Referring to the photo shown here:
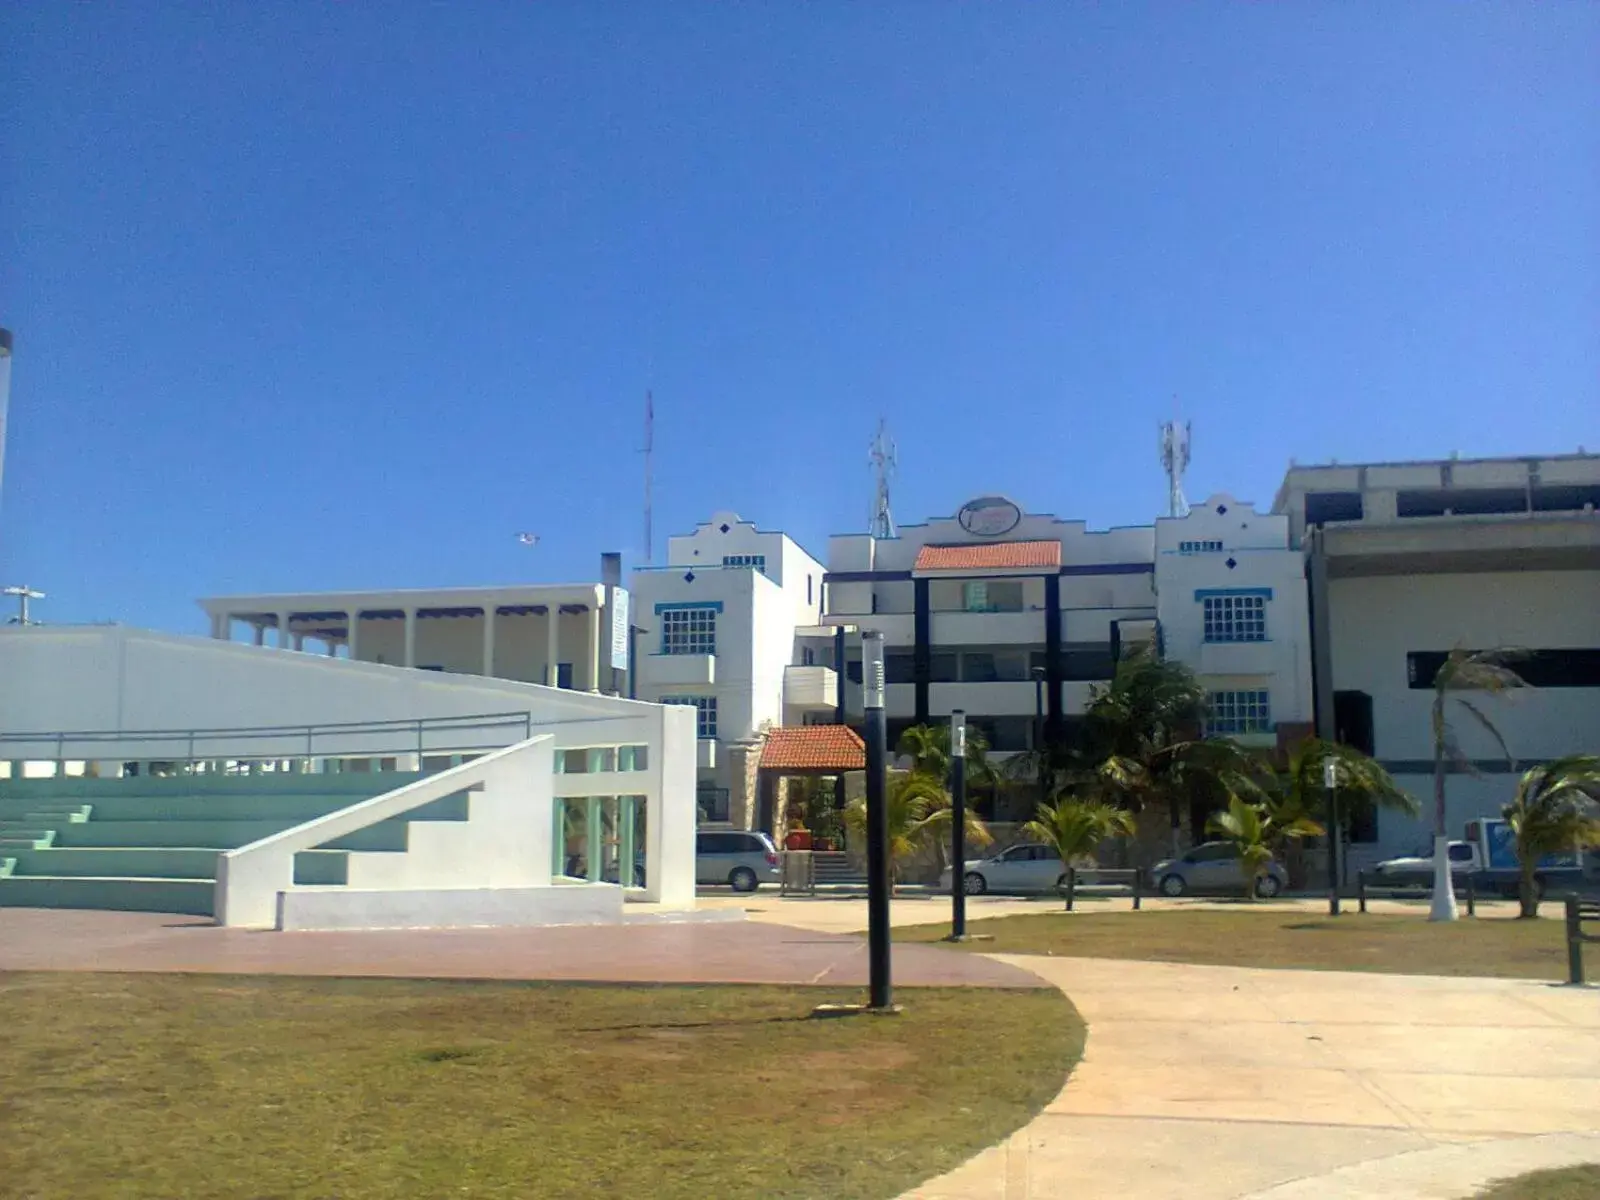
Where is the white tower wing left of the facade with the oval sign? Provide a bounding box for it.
[632,512,834,818]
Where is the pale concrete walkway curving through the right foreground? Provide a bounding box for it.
[909,957,1600,1200]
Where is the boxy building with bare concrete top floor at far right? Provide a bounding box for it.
[1274,454,1600,861]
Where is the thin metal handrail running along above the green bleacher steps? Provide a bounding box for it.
[0,710,534,762]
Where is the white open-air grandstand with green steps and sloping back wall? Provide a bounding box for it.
[0,622,694,928]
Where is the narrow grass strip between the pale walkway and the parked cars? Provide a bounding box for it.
[896,904,1566,979]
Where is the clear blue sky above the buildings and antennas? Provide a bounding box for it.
[0,2,1600,630]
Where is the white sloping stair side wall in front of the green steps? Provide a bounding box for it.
[214,733,555,926]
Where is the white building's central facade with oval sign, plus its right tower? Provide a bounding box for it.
[824,496,1310,780]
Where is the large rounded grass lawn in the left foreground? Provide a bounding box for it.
[0,973,1083,1200]
